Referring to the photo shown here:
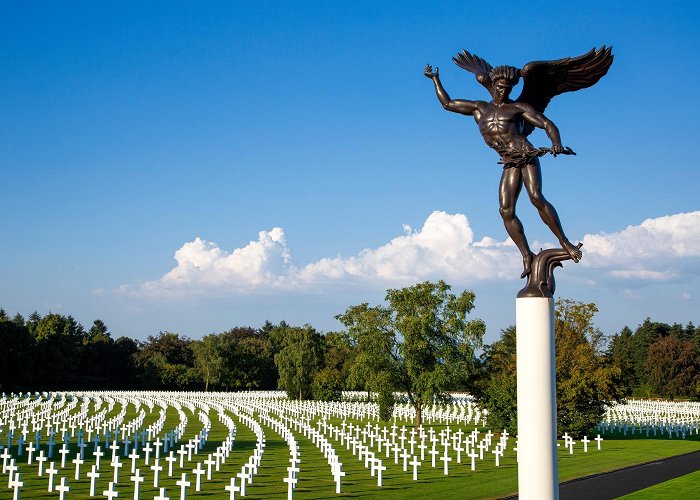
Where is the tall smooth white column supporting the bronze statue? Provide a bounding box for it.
[515,297,559,500]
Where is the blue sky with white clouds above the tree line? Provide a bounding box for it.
[0,2,700,340]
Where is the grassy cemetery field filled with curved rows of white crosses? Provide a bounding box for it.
[0,392,700,500]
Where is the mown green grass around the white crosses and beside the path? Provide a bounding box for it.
[5,405,700,500]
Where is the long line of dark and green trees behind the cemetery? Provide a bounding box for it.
[0,281,700,434]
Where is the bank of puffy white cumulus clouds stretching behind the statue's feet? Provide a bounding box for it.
[121,211,700,296]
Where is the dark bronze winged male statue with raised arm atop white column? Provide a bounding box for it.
[424,46,613,292]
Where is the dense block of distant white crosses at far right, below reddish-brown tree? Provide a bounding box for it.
[598,399,700,439]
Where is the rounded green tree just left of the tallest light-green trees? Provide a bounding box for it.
[275,324,323,399]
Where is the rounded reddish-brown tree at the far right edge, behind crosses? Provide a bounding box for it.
[645,335,700,399]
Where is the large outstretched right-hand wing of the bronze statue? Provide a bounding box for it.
[517,45,613,136]
